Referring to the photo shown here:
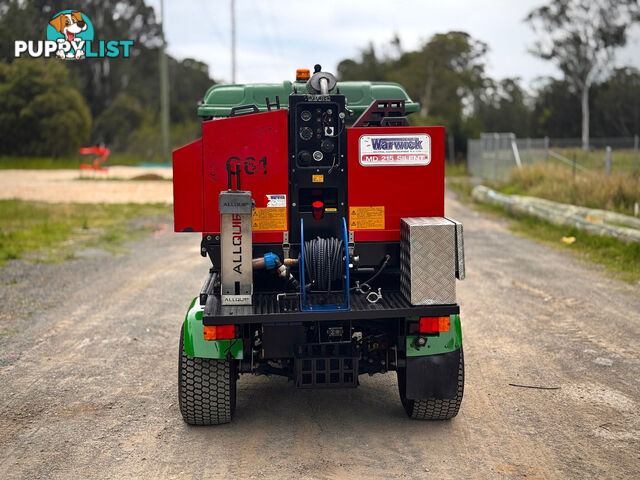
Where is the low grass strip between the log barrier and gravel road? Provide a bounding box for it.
[447,178,640,284]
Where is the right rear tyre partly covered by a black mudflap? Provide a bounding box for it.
[398,347,464,420]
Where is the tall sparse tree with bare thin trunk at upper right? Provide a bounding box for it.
[526,0,640,149]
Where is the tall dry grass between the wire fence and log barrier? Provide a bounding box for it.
[490,164,640,215]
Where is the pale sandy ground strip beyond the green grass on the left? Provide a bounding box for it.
[0,167,173,203]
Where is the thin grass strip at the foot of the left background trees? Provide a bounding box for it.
[0,153,162,170]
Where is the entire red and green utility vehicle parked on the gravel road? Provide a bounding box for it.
[173,65,464,424]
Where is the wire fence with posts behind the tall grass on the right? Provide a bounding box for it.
[467,132,640,180]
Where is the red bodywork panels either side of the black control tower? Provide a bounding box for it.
[173,116,444,243]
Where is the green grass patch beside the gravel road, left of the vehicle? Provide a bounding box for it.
[0,200,171,265]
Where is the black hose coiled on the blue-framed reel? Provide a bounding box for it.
[304,237,345,292]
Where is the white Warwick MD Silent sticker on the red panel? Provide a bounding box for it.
[359,133,431,167]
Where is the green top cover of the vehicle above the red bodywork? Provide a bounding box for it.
[198,81,420,118]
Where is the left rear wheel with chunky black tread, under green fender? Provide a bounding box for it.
[178,326,236,425]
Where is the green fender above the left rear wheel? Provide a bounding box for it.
[184,297,243,360]
